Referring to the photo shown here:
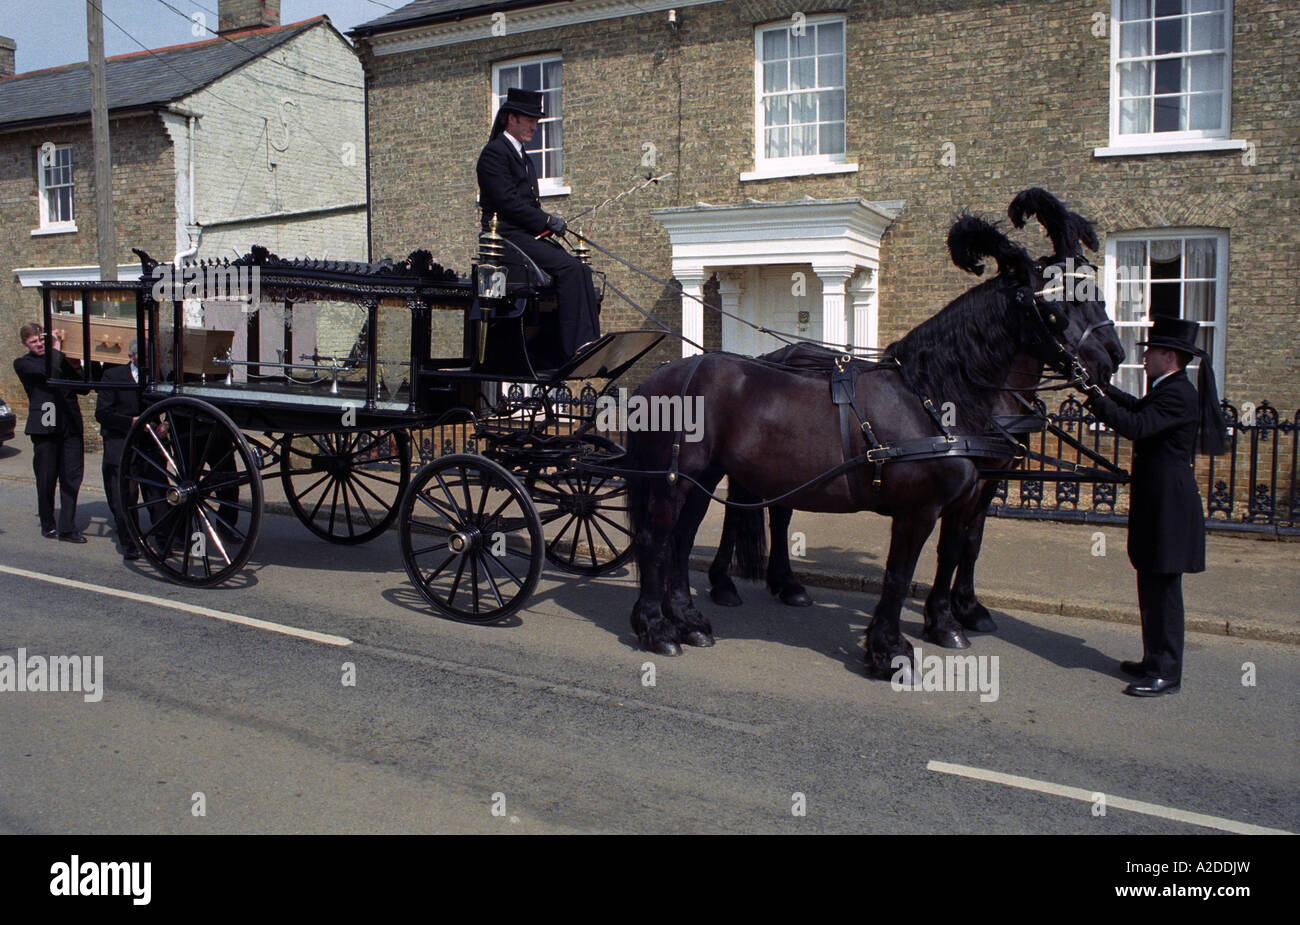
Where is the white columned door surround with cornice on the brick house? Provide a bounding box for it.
[650,197,904,356]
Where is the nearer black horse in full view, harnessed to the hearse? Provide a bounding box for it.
[628,190,1122,677]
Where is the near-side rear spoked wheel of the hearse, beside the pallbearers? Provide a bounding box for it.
[118,398,261,587]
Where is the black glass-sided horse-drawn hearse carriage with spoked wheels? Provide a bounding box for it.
[42,239,663,622]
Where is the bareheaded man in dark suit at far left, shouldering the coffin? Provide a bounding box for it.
[13,322,90,543]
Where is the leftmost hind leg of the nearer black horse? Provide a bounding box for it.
[629,479,681,655]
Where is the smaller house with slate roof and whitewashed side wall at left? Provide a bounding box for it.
[0,0,367,409]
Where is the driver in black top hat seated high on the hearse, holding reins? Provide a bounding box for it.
[477,87,601,356]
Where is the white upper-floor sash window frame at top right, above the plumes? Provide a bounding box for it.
[1093,0,1247,157]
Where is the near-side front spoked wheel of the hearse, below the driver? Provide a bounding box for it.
[398,453,543,624]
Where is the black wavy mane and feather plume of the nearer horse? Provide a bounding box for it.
[885,214,1034,429]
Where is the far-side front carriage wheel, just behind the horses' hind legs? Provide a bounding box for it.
[528,434,632,576]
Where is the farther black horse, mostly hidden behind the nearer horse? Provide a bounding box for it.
[709,188,1125,633]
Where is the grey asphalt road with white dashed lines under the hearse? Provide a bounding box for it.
[0,474,1300,834]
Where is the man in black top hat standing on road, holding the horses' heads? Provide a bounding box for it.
[1086,317,1226,696]
